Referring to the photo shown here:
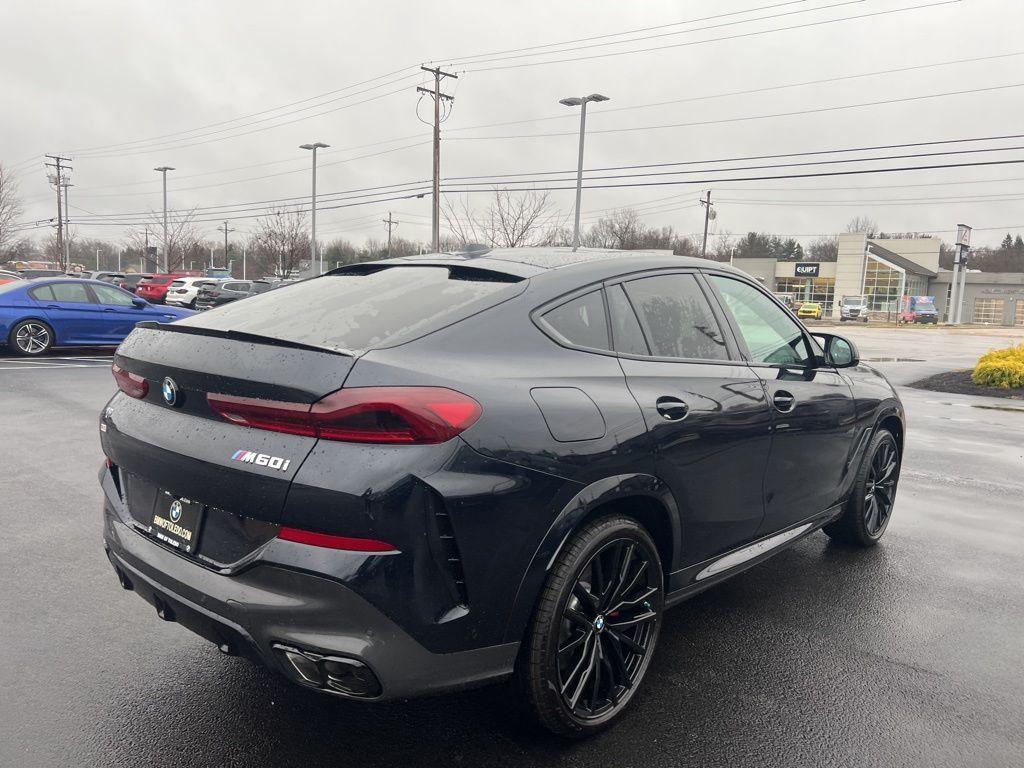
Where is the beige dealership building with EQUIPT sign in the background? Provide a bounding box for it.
[733,232,1024,327]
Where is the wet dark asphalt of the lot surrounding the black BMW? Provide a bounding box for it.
[0,328,1024,768]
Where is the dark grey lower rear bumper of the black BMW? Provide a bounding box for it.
[103,480,519,700]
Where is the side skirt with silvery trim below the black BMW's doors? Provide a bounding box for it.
[665,504,843,607]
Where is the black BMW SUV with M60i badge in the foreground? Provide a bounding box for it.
[99,249,904,735]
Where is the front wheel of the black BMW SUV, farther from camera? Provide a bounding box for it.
[822,429,902,547]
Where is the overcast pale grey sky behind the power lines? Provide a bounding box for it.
[0,0,1024,244]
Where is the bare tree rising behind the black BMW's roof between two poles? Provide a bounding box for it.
[441,187,565,248]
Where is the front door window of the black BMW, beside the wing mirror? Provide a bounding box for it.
[710,275,811,366]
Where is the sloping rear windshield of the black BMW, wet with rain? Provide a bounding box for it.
[177,266,525,352]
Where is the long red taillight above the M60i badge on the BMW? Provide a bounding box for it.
[207,387,483,444]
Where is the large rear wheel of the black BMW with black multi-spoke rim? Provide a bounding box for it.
[516,515,665,738]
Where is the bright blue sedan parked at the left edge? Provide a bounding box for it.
[0,278,195,355]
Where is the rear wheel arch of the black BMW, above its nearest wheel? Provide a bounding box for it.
[505,474,682,641]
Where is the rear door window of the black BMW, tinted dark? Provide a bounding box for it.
[626,273,729,360]
